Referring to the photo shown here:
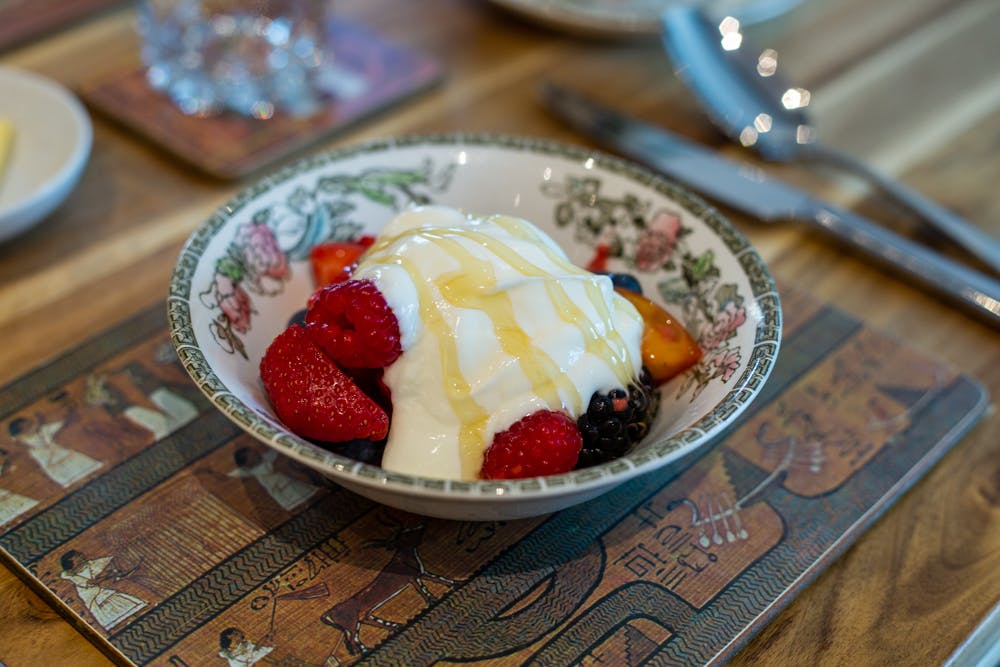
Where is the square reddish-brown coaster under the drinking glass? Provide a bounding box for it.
[80,22,442,179]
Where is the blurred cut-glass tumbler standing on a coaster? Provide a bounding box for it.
[137,0,340,119]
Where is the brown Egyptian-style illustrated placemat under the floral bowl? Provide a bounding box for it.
[0,292,987,667]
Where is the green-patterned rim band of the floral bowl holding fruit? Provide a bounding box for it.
[167,132,782,504]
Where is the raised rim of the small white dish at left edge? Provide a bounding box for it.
[0,66,94,232]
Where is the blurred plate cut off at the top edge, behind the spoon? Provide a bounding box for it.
[493,0,800,37]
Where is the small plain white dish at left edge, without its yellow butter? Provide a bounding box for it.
[0,67,93,242]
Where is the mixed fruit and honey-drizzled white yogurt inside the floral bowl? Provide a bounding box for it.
[261,205,701,481]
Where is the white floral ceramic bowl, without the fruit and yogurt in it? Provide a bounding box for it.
[168,135,781,520]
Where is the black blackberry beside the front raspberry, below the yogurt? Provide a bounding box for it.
[576,368,660,468]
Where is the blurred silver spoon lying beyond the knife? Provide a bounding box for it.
[663,4,1000,273]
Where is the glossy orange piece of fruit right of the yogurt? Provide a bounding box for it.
[615,287,702,385]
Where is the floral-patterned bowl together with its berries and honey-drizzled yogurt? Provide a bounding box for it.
[168,135,780,520]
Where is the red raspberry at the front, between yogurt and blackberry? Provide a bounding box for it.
[479,410,583,479]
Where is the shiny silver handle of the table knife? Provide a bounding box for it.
[809,204,1000,328]
